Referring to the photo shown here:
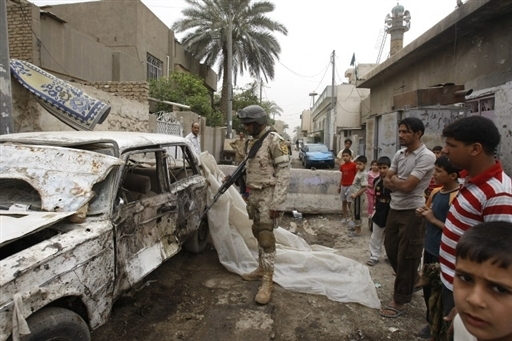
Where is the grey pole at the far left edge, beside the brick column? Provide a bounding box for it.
[0,0,14,135]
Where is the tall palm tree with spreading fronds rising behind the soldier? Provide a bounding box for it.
[172,0,288,119]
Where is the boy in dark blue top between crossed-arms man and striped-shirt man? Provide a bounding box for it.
[416,155,460,338]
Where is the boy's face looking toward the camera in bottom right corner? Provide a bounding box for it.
[453,221,512,341]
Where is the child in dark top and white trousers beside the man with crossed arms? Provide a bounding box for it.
[366,156,391,266]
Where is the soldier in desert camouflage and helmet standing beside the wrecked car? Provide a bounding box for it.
[237,105,290,304]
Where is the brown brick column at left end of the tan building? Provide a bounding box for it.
[7,0,34,63]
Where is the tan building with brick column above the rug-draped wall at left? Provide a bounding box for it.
[7,0,217,90]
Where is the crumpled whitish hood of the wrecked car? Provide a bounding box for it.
[0,143,122,244]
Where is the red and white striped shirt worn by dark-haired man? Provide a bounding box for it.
[439,161,512,290]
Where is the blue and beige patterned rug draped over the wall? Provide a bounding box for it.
[10,59,110,130]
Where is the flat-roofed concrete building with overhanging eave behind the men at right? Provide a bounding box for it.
[358,0,512,174]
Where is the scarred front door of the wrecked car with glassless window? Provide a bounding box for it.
[114,149,179,297]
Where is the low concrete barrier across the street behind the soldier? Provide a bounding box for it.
[219,165,366,214]
